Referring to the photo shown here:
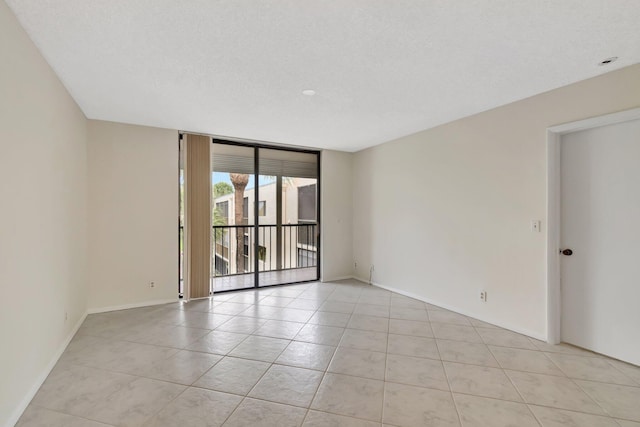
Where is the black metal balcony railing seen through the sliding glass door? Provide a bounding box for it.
[212,224,318,277]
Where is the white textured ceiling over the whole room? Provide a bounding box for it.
[6,0,640,151]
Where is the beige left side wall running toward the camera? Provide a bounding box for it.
[0,1,87,426]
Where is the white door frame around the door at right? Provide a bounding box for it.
[547,107,640,344]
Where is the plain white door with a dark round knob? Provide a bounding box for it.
[561,120,640,364]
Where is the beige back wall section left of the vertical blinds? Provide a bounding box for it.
[88,120,178,311]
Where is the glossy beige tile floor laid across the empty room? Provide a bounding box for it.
[18,281,640,427]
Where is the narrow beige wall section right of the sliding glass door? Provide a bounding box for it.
[320,150,356,282]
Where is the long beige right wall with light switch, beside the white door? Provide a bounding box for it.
[353,65,640,338]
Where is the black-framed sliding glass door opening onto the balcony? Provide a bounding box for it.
[211,140,320,292]
